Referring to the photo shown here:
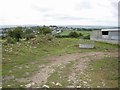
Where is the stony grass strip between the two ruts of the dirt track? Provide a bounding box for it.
[46,61,75,88]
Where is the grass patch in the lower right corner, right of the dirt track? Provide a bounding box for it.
[81,57,118,88]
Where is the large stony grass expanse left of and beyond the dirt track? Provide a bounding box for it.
[2,34,118,87]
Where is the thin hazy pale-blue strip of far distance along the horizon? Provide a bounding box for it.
[0,25,117,29]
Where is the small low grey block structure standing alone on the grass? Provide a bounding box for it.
[79,39,94,48]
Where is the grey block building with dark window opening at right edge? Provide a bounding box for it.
[90,29,120,44]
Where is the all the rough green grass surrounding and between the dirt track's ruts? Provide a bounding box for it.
[2,35,118,88]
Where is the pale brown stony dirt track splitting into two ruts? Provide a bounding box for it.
[18,52,117,87]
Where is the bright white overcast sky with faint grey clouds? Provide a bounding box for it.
[0,0,119,26]
